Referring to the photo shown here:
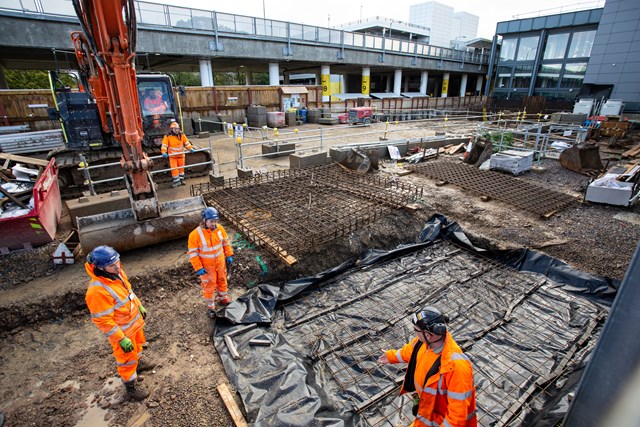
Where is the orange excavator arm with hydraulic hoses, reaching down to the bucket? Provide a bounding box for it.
[71,0,153,199]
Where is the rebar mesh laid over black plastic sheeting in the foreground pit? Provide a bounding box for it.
[272,242,604,426]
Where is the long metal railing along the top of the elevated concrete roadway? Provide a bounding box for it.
[0,0,489,65]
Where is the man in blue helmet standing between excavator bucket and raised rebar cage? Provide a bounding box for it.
[188,207,233,318]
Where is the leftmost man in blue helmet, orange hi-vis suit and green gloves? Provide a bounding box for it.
[85,246,152,401]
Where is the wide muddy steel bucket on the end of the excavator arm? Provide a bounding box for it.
[77,196,206,253]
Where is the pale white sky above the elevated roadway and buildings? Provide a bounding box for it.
[144,0,604,39]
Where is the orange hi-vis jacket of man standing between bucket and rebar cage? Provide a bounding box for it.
[187,224,233,271]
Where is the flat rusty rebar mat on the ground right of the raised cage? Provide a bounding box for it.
[409,162,574,217]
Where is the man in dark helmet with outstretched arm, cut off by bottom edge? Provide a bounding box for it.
[378,306,478,427]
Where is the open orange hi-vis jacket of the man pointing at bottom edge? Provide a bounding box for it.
[385,332,478,427]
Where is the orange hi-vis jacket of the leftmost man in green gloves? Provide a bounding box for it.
[85,263,144,345]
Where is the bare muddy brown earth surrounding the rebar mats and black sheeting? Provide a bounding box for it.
[0,121,640,426]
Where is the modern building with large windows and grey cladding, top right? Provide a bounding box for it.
[485,0,640,111]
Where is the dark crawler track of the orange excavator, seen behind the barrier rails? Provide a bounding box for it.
[51,147,211,200]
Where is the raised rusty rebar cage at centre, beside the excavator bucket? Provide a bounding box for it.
[192,165,422,265]
